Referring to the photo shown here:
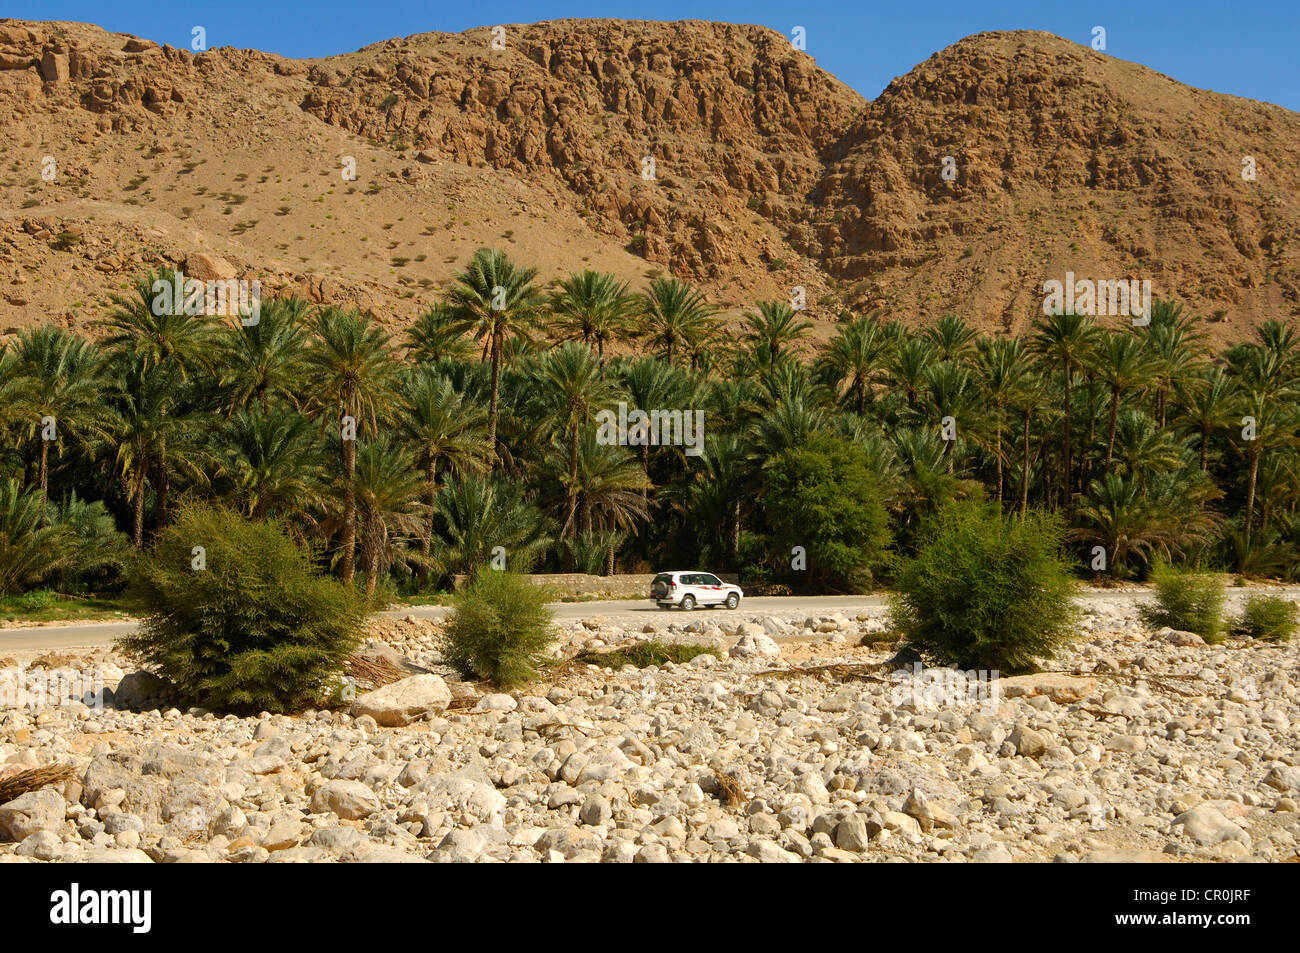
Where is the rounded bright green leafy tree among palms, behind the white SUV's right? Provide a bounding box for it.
[762,434,889,589]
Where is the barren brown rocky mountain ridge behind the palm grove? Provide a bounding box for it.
[0,20,1300,338]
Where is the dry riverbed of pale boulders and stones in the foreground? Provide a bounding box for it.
[0,593,1300,863]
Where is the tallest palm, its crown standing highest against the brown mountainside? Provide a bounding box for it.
[447,248,542,467]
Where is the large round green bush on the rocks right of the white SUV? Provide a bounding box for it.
[891,502,1078,673]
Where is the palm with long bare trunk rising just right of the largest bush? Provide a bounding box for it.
[307,308,395,582]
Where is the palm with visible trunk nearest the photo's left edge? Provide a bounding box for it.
[10,324,105,499]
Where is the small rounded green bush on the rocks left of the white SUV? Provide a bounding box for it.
[446,569,553,688]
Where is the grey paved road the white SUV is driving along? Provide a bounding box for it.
[10,588,1300,653]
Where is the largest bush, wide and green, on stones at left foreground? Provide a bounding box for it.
[121,503,365,711]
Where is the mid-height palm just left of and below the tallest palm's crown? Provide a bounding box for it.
[398,368,491,556]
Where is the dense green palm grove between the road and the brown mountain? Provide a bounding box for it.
[0,250,1300,595]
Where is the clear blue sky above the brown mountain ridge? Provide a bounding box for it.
[12,0,1300,112]
